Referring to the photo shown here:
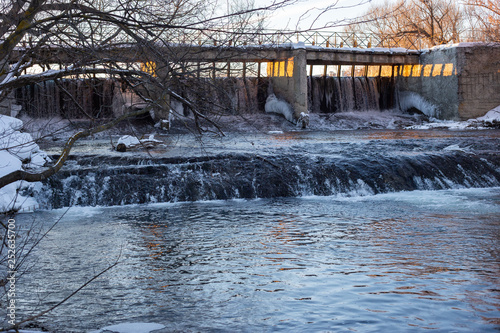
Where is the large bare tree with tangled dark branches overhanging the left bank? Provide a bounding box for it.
[0,0,304,188]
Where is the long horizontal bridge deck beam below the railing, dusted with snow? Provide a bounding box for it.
[11,44,420,65]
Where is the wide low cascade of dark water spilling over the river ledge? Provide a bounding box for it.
[36,147,500,208]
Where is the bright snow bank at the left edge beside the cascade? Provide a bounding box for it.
[0,115,49,212]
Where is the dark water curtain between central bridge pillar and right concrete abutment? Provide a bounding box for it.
[308,77,395,113]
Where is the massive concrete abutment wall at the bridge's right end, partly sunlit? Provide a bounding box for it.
[397,43,500,120]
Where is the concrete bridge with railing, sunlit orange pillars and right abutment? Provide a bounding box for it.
[7,31,500,119]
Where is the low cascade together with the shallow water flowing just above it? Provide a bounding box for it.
[36,130,500,208]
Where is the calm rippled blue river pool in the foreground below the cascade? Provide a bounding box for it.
[13,188,500,332]
